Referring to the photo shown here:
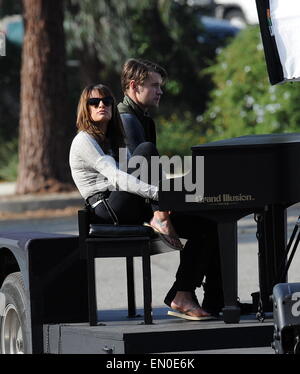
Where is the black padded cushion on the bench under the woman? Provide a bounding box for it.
[89,223,156,238]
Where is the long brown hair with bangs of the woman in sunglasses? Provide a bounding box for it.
[76,84,125,160]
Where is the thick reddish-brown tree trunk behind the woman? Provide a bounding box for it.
[16,0,73,194]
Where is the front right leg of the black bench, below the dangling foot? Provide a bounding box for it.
[142,250,152,325]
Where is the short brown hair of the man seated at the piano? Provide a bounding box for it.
[121,58,167,92]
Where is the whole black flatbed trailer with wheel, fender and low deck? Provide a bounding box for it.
[0,232,273,354]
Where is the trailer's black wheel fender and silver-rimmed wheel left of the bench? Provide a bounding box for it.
[0,232,87,353]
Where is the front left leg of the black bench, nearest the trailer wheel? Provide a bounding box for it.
[87,248,97,326]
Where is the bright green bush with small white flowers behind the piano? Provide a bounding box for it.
[202,27,300,140]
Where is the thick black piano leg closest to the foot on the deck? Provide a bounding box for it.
[218,222,240,323]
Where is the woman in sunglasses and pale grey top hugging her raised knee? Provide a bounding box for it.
[70,85,182,245]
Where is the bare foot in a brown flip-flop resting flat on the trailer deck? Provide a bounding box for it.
[171,291,210,317]
